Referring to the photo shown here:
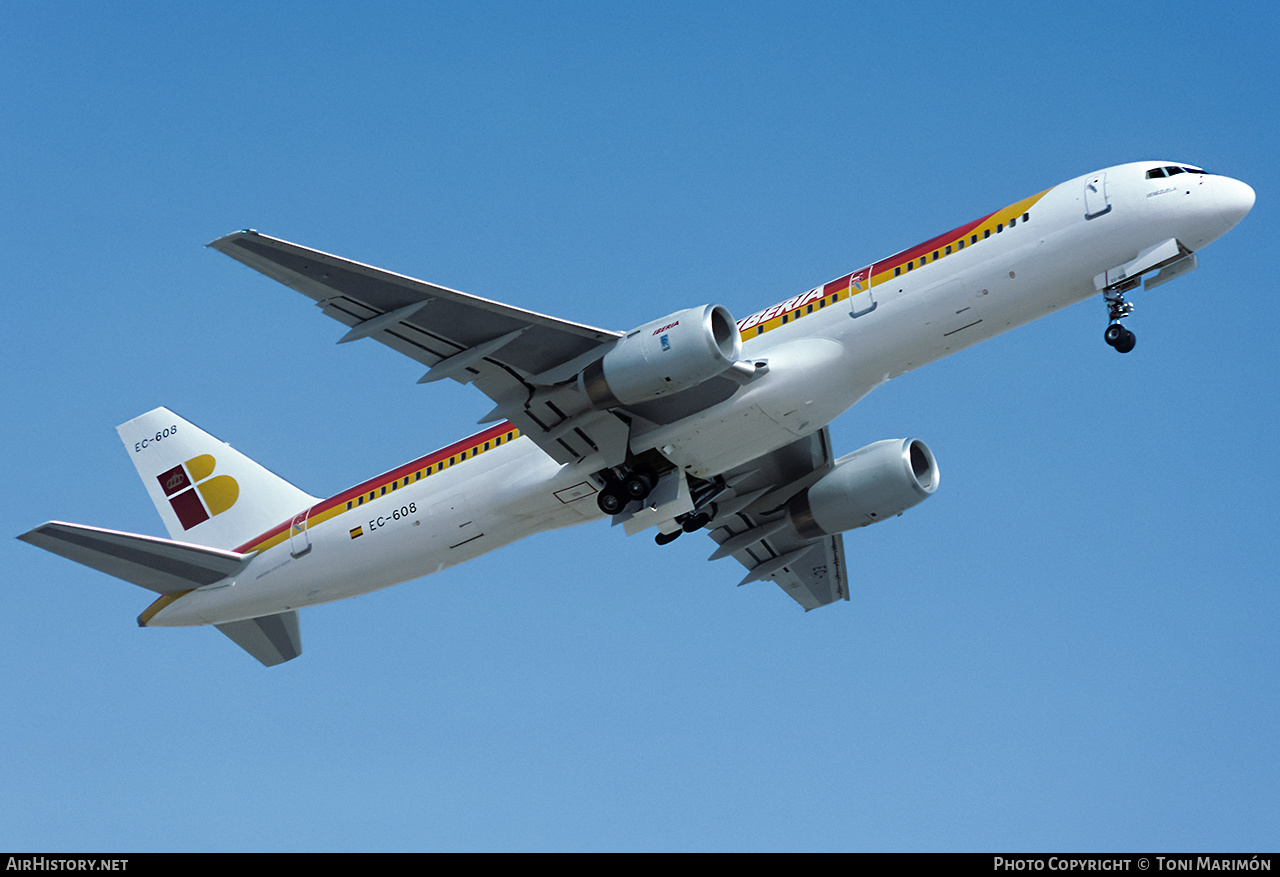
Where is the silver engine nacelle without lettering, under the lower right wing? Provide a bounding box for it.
[787,439,938,539]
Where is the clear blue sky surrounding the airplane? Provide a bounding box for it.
[0,1,1280,851]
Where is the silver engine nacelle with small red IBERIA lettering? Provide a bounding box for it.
[579,305,742,408]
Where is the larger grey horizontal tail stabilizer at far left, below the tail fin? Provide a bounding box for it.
[18,521,253,594]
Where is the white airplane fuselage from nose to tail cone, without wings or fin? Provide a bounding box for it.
[146,161,1253,626]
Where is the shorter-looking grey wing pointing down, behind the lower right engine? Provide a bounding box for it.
[708,428,849,611]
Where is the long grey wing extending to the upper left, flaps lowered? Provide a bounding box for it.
[209,230,630,465]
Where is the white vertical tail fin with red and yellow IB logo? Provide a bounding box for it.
[115,408,316,548]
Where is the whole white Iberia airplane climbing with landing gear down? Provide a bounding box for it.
[18,161,1254,666]
